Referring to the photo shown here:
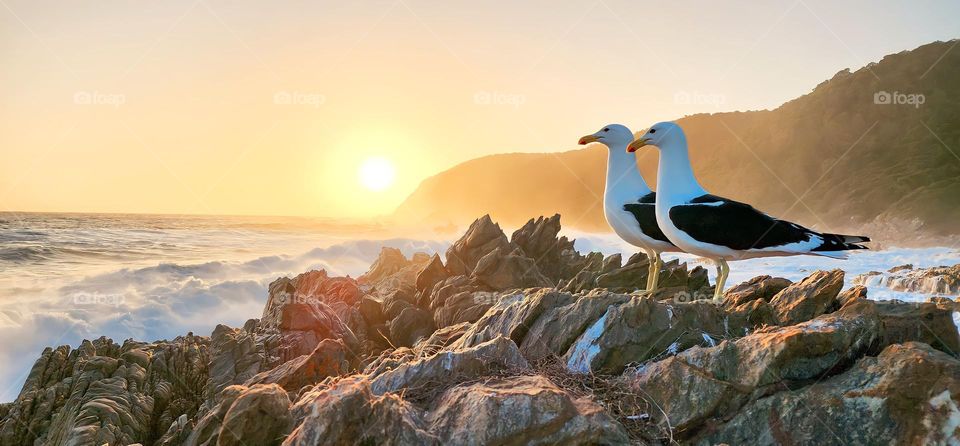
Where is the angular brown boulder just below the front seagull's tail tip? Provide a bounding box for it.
[770,269,843,325]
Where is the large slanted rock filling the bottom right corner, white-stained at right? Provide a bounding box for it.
[697,342,960,445]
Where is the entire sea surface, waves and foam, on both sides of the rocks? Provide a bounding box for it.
[0,213,960,401]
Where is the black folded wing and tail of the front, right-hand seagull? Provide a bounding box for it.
[670,194,870,251]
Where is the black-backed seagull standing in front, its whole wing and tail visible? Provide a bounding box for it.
[627,122,870,303]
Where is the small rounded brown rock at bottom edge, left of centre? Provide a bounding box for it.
[216,384,293,446]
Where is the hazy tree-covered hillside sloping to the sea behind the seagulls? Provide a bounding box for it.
[395,41,960,242]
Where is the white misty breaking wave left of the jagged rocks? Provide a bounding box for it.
[0,238,449,401]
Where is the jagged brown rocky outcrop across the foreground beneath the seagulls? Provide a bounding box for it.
[0,217,960,446]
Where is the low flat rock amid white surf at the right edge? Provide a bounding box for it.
[853,264,960,296]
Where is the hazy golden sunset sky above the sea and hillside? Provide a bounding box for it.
[0,0,960,217]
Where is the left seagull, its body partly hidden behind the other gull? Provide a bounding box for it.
[580,124,680,292]
